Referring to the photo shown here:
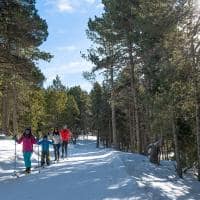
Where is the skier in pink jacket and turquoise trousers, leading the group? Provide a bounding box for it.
[17,128,37,173]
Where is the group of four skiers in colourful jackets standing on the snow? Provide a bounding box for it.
[15,125,72,173]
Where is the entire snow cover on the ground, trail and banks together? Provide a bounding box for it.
[0,136,200,200]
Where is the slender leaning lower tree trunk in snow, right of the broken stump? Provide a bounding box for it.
[172,113,183,178]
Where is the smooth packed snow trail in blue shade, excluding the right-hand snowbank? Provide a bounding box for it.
[0,139,138,200]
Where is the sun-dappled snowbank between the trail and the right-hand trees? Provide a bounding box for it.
[119,153,200,200]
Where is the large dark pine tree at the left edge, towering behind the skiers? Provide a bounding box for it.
[0,0,51,132]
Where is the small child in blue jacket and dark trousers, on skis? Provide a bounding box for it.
[38,135,53,167]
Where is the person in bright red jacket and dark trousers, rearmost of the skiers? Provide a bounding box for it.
[60,125,72,158]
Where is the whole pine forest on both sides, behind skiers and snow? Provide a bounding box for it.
[0,0,200,180]
